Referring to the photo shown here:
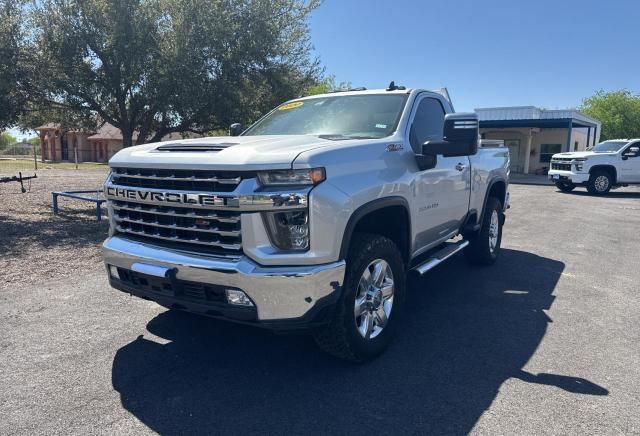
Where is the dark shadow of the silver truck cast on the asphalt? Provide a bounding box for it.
[112,249,608,434]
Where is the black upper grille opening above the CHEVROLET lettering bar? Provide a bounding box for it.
[111,168,248,192]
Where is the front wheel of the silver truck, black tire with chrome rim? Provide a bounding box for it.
[314,234,405,362]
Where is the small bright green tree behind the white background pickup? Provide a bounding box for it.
[580,89,640,140]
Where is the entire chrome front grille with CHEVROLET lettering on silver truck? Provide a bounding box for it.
[104,168,310,257]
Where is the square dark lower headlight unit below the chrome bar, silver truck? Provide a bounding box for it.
[264,210,309,251]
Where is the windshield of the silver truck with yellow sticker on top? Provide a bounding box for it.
[245,94,407,139]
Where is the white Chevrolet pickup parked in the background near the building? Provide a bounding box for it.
[549,139,640,195]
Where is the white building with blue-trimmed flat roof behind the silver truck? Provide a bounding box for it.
[476,106,601,174]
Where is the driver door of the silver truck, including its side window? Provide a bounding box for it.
[409,93,471,251]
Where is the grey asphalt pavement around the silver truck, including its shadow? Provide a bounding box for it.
[0,185,640,435]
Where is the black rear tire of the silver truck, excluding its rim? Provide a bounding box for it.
[464,197,504,265]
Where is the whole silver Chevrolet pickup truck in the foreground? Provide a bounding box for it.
[104,86,509,361]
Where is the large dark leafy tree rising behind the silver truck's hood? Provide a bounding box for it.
[30,0,321,146]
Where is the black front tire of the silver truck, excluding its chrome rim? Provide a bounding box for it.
[313,233,406,362]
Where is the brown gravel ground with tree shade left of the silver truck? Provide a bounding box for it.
[0,168,108,290]
